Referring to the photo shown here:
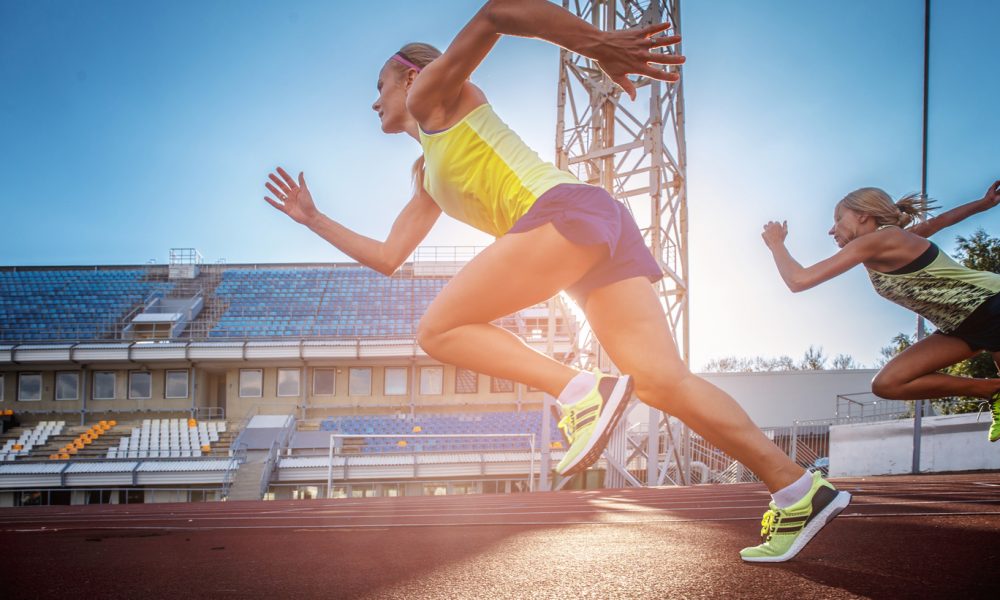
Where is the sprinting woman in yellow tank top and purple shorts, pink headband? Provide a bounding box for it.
[265,0,850,561]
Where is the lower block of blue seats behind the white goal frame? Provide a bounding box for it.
[320,411,564,453]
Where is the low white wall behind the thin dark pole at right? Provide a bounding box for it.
[830,414,1000,477]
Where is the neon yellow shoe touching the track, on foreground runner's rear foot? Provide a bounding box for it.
[740,471,851,562]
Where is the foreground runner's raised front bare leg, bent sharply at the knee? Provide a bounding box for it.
[417,224,607,396]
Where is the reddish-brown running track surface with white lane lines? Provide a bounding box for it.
[0,473,1000,600]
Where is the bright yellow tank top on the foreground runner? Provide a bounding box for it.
[420,104,581,237]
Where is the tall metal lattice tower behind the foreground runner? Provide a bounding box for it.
[556,0,689,487]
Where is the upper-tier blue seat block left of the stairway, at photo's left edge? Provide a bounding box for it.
[0,269,172,341]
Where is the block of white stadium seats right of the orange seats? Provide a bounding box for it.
[107,419,226,458]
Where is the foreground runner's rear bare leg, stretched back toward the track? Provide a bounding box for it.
[584,278,804,492]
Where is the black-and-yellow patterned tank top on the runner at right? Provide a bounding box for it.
[868,243,1000,333]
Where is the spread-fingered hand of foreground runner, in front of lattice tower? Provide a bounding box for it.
[588,23,684,100]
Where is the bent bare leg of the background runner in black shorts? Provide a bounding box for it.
[872,335,1000,400]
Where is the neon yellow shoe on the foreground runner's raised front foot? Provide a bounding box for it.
[556,371,632,477]
